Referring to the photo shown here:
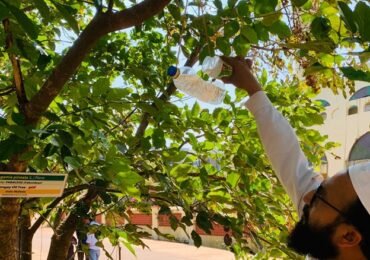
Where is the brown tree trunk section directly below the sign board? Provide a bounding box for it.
[0,198,20,260]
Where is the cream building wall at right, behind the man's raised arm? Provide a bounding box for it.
[317,82,370,176]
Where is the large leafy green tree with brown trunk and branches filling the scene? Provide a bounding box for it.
[0,0,370,259]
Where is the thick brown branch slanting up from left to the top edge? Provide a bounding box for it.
[26,0,170,124]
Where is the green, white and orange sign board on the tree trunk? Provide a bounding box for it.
[0,172,67,197]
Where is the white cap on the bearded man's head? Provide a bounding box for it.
[349,162,370,214]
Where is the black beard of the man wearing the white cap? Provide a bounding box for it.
[288,205,339,259]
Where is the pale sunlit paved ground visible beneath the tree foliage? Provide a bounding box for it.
[32,227,234,260]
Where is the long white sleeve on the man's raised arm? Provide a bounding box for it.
[245,91,322,215]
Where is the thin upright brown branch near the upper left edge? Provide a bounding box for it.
[3,19,28,113]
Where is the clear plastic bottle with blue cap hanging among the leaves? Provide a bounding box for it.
[167,66,226,104]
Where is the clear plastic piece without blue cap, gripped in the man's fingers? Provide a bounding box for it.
[202,56,233,79]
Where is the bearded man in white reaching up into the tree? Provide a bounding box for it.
[222,57,370,260]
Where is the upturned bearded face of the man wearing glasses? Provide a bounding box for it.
[288,173,356,259]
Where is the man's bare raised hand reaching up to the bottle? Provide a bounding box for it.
[221,56,262,96]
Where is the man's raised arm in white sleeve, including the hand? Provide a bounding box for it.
[223,57,322,214]
